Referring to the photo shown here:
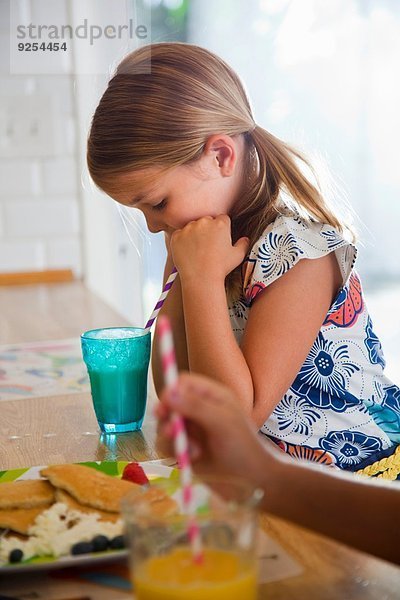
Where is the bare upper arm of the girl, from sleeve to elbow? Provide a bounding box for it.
[242,252,342,426]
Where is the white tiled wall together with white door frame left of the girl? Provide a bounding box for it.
[0,0,150,325]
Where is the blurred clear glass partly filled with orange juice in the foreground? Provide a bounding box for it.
[122,476,263,600]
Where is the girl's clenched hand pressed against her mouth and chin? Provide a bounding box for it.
[170,215,249,282]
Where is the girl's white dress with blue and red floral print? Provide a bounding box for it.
[229,215,400,470]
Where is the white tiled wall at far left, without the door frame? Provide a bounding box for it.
[0,0,82,276]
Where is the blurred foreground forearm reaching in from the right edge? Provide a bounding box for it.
[258,438,400,564]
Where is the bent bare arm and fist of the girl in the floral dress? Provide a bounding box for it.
[171,215,341,427]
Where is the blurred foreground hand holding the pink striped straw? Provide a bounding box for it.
[156,373,272,484]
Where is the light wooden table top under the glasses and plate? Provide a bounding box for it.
[0,281,400,600]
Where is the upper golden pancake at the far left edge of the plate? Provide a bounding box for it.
[0,479,54,510]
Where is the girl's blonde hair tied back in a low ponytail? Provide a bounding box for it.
[87,42,345,302]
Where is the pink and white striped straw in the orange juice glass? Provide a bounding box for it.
[157,316,203,563]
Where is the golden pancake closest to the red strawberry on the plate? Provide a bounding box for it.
[40,464,141,513]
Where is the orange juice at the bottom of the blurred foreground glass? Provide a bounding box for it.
[133,547,257,600]
